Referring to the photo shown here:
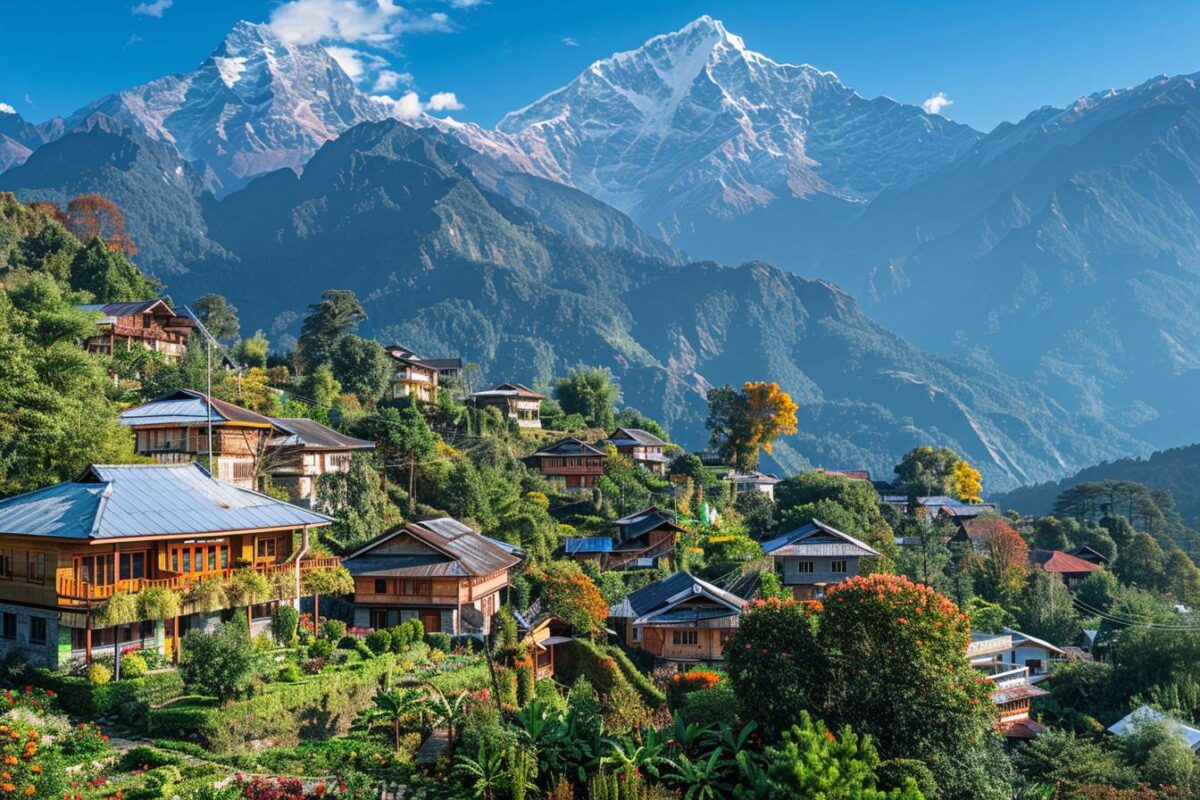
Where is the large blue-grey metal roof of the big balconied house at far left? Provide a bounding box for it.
[0,463,332,539]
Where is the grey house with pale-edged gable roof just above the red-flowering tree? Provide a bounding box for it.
[762,519,878,600]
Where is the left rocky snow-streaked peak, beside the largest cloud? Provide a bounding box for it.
[66,22,390,194]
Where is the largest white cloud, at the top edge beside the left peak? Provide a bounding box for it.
[270,0,451,47]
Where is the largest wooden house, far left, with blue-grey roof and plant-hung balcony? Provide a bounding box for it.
[0,464,338,667]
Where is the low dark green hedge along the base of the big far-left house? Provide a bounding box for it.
[29,668,184,728]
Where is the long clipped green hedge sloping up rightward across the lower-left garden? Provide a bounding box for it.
[142,654,395,754]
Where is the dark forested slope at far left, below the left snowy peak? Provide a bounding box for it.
[0,114,229,279]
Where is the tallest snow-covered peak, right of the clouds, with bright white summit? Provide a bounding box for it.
[482,17,978,265]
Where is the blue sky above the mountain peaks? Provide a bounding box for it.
[0,0,1200,130]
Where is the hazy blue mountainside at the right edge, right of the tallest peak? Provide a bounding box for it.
[824,76,1200,446]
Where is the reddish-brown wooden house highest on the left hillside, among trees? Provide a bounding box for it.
[79,300,192,362]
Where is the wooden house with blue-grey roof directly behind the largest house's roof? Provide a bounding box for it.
[120,389,284,488]
